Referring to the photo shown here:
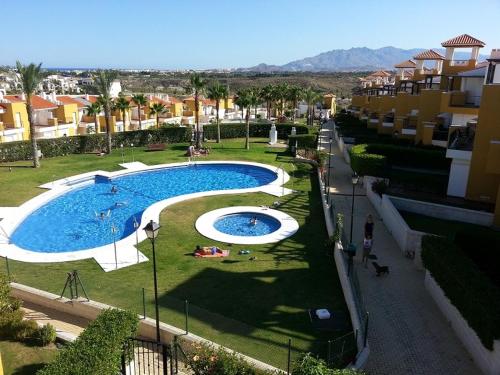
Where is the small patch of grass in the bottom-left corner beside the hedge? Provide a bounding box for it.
[0,340,57,375]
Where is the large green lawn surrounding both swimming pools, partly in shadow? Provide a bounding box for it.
[0,140,346,366]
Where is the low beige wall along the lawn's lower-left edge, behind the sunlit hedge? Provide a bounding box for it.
[11,283,282,373]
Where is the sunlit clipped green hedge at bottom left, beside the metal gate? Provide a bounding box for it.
[37,309,139,375]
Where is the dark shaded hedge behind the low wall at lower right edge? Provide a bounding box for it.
[422,236,500,350]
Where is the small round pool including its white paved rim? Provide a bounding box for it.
[195,206,299,245]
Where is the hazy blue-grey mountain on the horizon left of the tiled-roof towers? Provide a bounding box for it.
[238,47,486,73]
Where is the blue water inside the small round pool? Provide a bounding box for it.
[214,212,281,236]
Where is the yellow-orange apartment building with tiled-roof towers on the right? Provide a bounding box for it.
[349,34,500,226]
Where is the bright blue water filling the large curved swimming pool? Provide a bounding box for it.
[11,164,276,252]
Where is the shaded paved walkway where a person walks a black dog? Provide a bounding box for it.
[322,122,481,375]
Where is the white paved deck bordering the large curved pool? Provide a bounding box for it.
[0,161,292,272]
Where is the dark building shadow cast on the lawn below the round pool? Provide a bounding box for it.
[160,170,346,355]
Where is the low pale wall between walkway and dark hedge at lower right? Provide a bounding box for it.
[425,271,500,375]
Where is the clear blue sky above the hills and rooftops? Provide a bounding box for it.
[0,0,500,69]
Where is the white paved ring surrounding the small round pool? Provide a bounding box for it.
[195,206,299,245]
